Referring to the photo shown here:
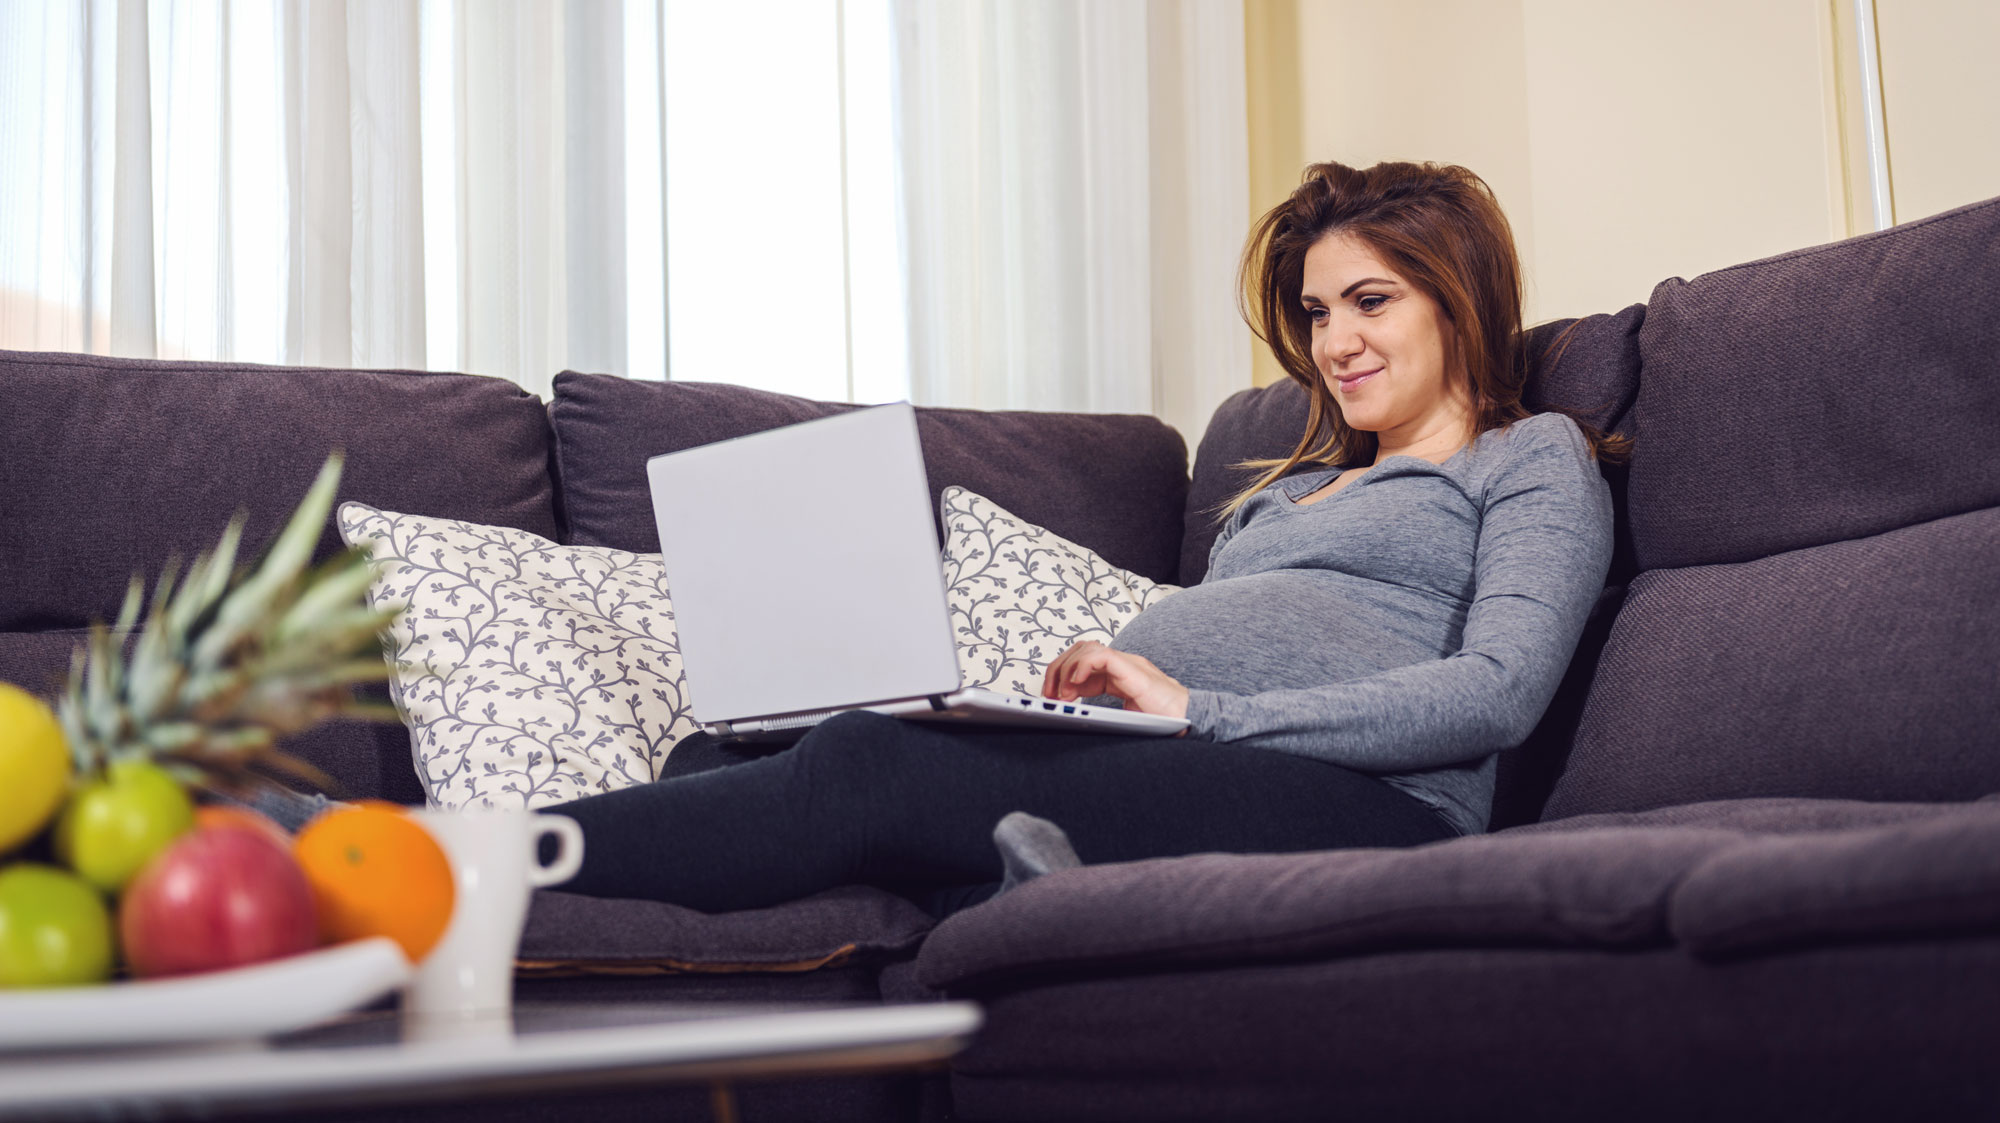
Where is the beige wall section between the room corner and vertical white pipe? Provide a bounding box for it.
[1520,0,1846,322]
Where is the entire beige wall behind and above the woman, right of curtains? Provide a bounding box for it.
[1246,0,2000,384]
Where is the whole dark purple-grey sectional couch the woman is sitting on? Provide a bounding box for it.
[0,191,2000,1119]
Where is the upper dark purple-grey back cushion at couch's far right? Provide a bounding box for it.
[1630,190,2000,569]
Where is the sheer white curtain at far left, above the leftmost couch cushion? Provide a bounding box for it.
[0,0,666,392]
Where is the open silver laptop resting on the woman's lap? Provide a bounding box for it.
[646,404,1188,739]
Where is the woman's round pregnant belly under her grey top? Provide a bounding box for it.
[1112,569,1466,693]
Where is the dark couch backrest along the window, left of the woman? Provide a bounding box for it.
[0,352,1188,803]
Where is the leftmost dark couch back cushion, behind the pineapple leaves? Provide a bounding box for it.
[0,352,556,631]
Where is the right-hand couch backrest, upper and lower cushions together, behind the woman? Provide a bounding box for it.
[1546,200,2000,817]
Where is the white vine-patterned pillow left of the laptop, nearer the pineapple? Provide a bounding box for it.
[340,504,696,809]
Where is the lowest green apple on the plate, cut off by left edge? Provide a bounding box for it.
[0,861,112,987]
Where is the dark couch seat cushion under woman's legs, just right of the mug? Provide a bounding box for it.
[518,885,934,973]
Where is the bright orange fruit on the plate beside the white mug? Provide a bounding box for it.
[292,801,456,963]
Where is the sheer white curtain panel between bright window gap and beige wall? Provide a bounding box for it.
[896,0,1250,442]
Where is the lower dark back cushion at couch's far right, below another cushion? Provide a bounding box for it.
[1546,508,2000,817]
